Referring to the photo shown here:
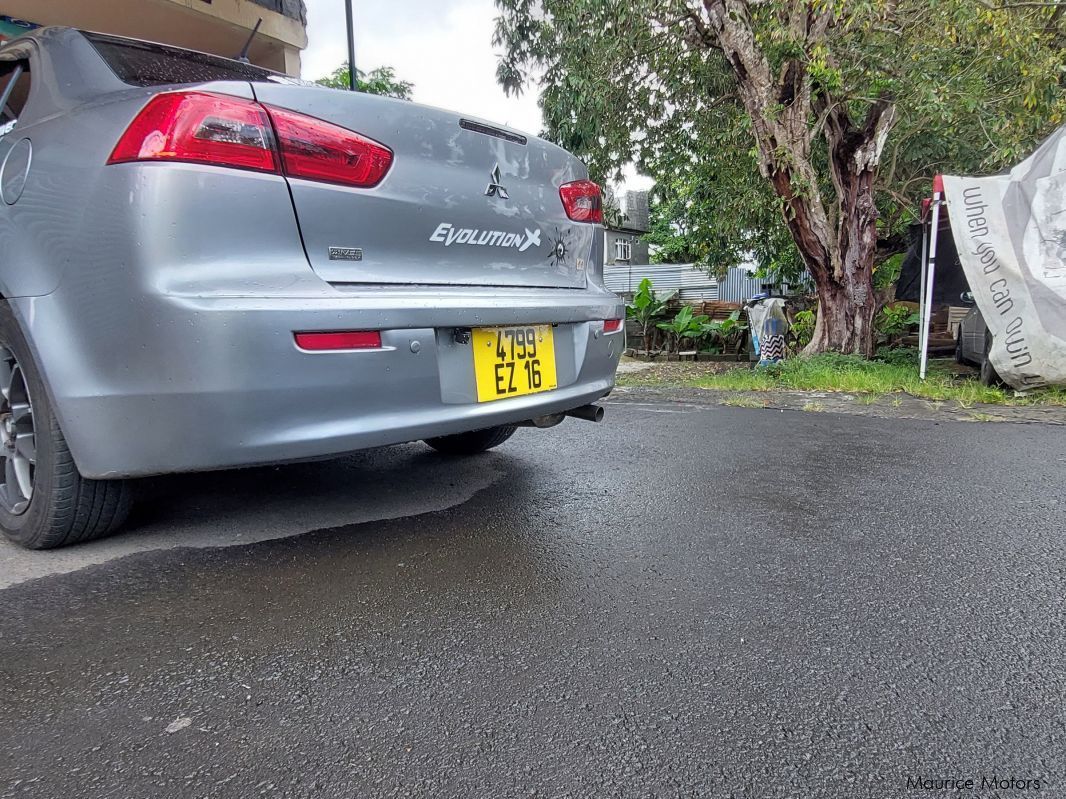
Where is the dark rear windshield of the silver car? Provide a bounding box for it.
[82,31,285,86]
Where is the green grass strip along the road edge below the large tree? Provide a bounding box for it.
[692,354,1066,406]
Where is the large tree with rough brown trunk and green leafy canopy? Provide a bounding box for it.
[496,0,1066,356]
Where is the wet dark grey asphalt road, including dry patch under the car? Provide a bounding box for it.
[0,393,1066,799]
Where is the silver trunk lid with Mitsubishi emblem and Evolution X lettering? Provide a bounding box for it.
[253,83,601,288]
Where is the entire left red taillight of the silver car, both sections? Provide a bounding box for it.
[108,92,392,189]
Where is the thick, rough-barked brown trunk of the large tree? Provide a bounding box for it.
[697,0,895,357]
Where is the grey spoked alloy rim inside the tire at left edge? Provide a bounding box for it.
[0,344,37,516]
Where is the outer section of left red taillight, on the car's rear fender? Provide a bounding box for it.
[108,92,278,172]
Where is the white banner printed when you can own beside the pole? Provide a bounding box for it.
[943,128,1066,389]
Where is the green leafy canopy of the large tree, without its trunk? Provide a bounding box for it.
[496,0,1066,280]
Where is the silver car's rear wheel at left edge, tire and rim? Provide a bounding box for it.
[0,300,130,550]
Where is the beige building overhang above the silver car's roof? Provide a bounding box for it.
[0,0,307,76]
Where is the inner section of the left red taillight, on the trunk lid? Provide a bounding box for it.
[268,107,392,189]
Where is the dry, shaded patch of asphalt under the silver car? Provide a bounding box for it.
[0,444,506,589]
